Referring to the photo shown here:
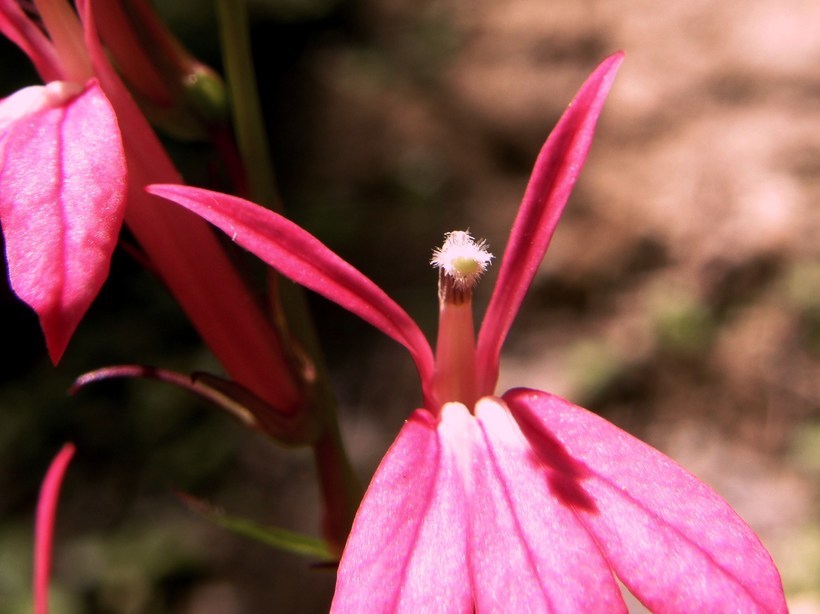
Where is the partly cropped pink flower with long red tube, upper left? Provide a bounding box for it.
[0,0,305,414]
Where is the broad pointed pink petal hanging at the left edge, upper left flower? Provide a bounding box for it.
[0,81,126,363]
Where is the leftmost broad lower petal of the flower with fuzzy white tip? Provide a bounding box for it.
[331,404,474,614]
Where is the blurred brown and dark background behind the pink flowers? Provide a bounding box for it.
[0,0,820,614]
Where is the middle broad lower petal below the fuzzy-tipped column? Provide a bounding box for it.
[469,397,626,612]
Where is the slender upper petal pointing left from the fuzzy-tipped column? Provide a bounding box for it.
[148,185,434,407]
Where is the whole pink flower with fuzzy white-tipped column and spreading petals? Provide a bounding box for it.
[149,54,786,612]
